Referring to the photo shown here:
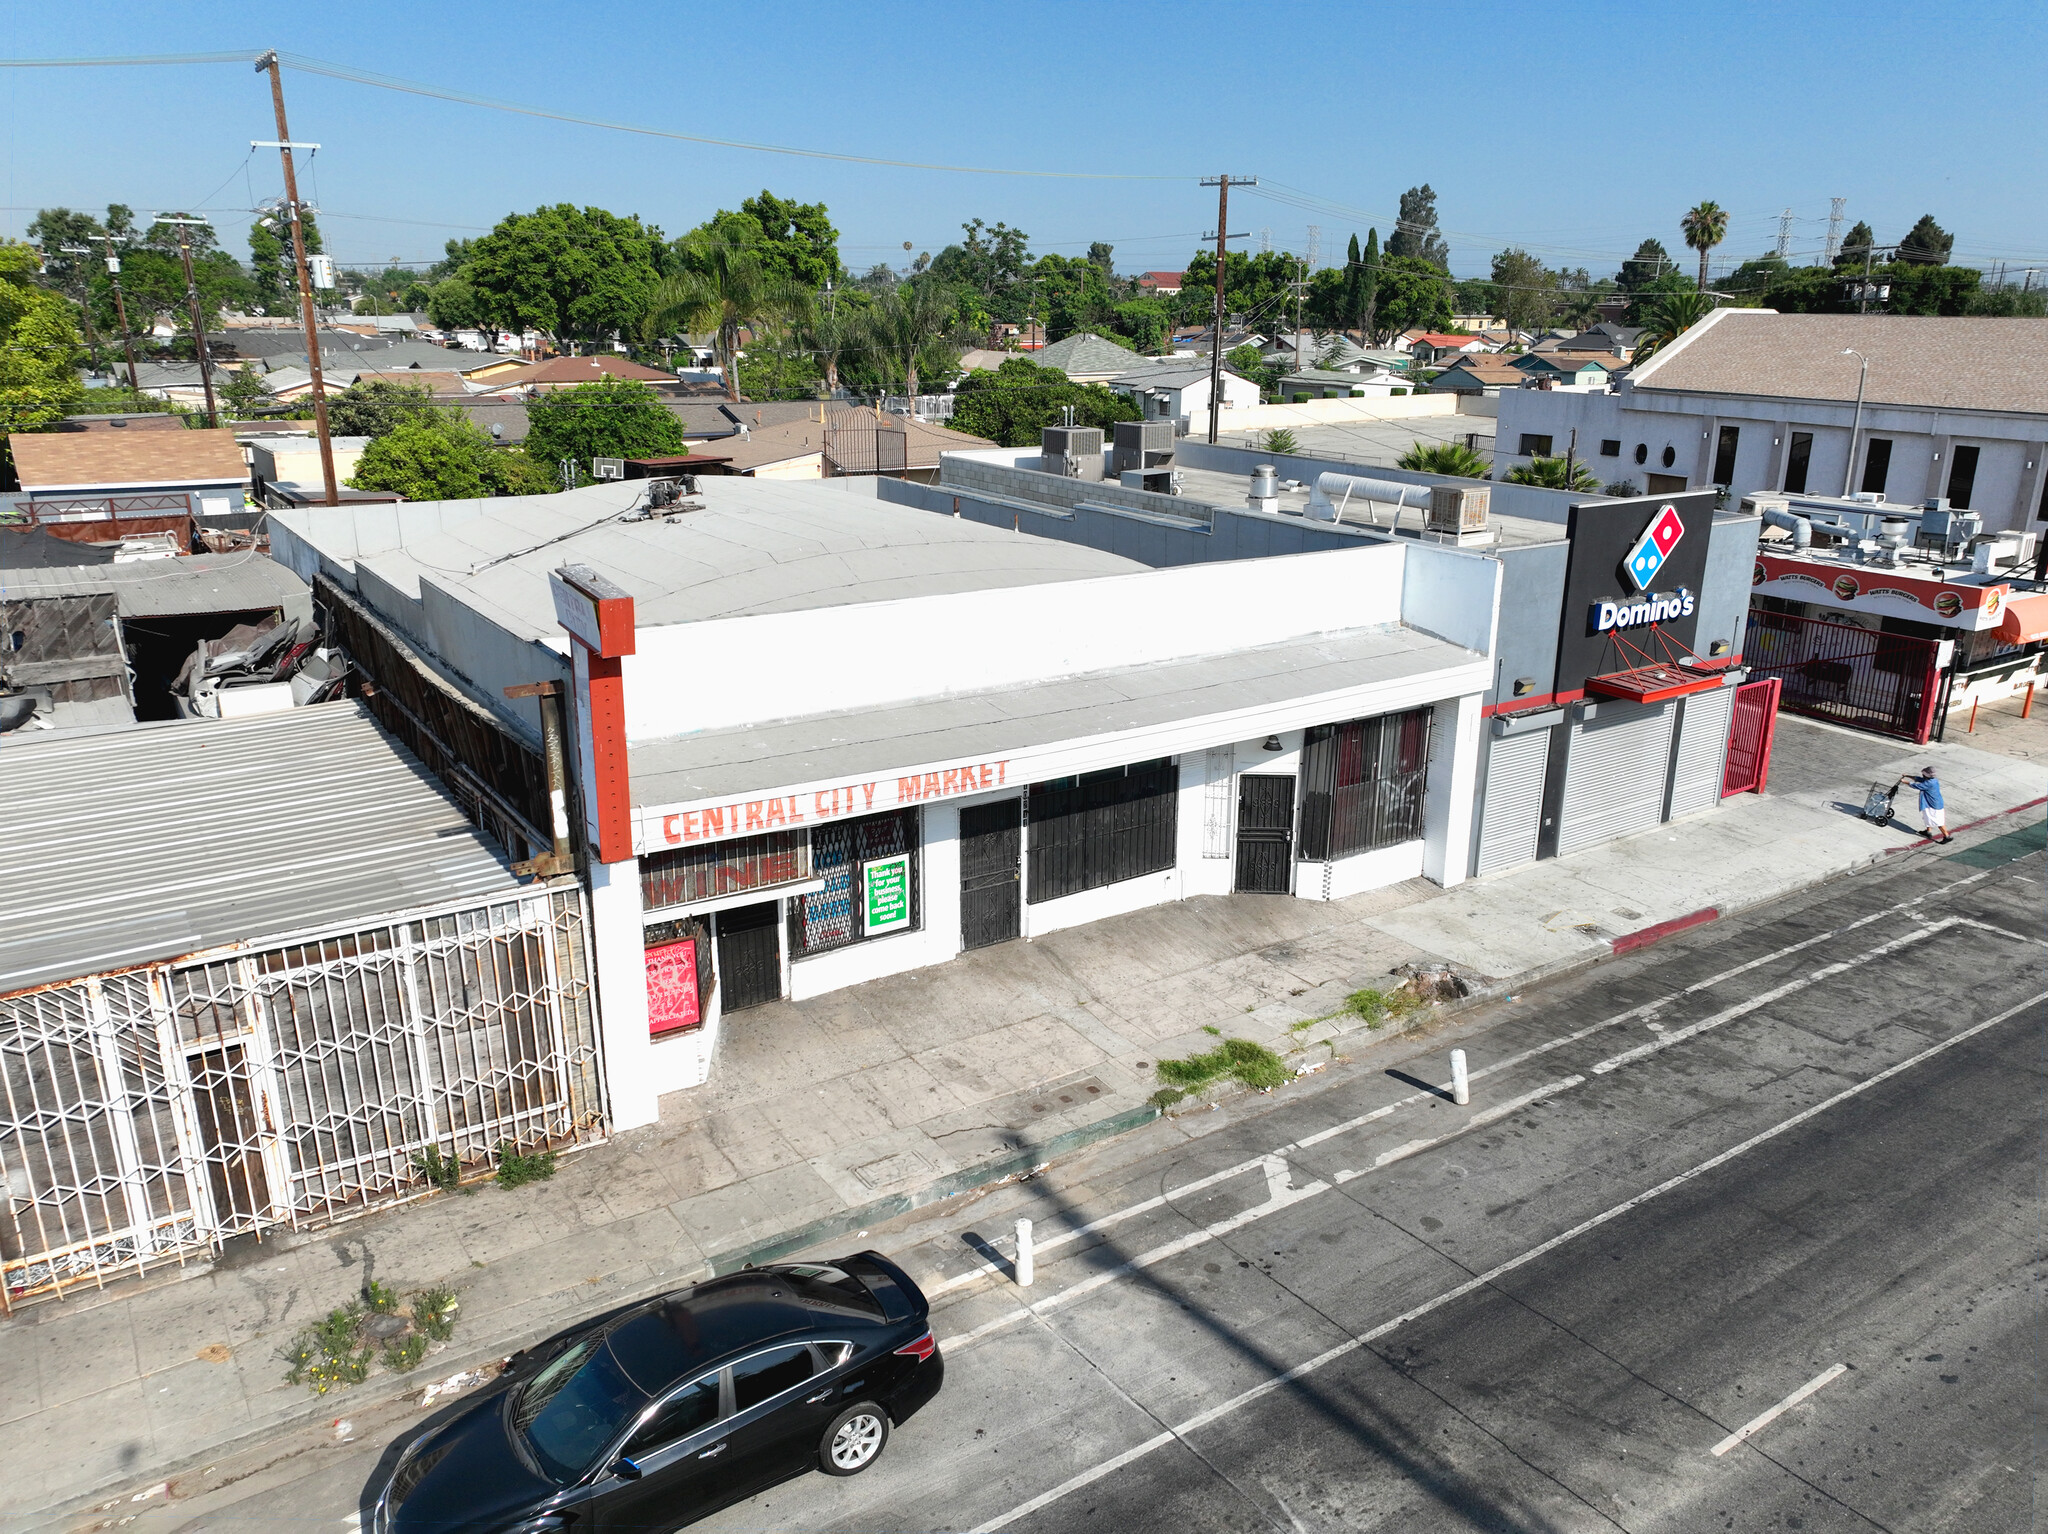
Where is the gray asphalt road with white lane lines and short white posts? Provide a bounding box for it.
[96,831,2048,1534]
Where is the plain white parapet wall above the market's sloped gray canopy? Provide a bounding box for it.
[625,543,1407,739]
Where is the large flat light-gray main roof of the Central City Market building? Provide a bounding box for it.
[299,475,1145,639]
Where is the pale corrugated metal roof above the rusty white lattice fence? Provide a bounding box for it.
[0,702,518,993]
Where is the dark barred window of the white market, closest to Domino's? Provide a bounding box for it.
[1300,709,1436,862]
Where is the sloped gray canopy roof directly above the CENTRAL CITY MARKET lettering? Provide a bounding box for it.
[627,627,1479,805]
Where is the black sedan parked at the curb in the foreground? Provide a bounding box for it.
[371,1251,946,1534]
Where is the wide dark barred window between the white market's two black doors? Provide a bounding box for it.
[1024,756,1180,905]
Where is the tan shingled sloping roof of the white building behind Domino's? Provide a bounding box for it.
[1632,309,2048,416]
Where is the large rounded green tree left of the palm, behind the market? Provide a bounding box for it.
[463,203,668,346]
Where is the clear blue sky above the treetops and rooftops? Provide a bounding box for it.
[0,0,2048,281]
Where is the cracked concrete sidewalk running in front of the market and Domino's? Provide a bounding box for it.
[0,719,2048,1528]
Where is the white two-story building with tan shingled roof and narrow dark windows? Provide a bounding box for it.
[1495,309,2048,532]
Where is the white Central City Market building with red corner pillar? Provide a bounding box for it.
[276,479,1501,1128]
